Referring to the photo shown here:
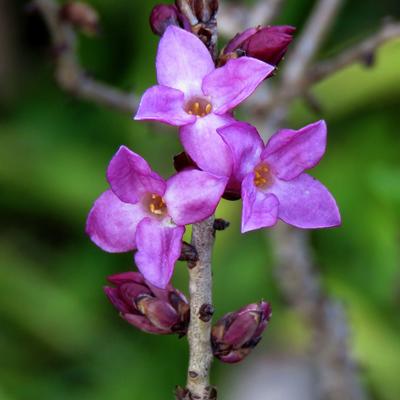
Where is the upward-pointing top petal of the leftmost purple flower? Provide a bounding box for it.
[107,146,166,204]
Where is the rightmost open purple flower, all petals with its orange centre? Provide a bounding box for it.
[218,121,340,233]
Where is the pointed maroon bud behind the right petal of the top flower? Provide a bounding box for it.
[221,25,296,65]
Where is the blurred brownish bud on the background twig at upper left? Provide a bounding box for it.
[60,1,99,36]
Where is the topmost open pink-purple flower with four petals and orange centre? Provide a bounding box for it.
[135,26,274,176]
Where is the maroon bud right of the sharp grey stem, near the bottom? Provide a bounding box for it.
[211,301,272,364]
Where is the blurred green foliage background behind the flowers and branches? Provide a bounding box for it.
[0,0,400,400]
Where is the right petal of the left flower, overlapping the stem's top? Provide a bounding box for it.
[164,170,228,225]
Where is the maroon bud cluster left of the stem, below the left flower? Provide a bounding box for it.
[104,272,190,336]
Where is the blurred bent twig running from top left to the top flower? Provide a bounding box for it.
[34,0,138,113]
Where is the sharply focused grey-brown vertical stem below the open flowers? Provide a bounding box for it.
[187,216,215,399]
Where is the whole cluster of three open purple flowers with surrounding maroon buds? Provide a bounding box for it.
[87,16,340,362]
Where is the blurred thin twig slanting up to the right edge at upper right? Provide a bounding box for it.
[308,22,400,84]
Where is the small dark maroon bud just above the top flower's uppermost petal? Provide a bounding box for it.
[150,4,191,36]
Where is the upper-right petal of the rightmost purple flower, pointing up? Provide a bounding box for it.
[261,120,327,181]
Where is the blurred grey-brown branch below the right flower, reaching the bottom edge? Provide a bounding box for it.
[272,224,366,400]
